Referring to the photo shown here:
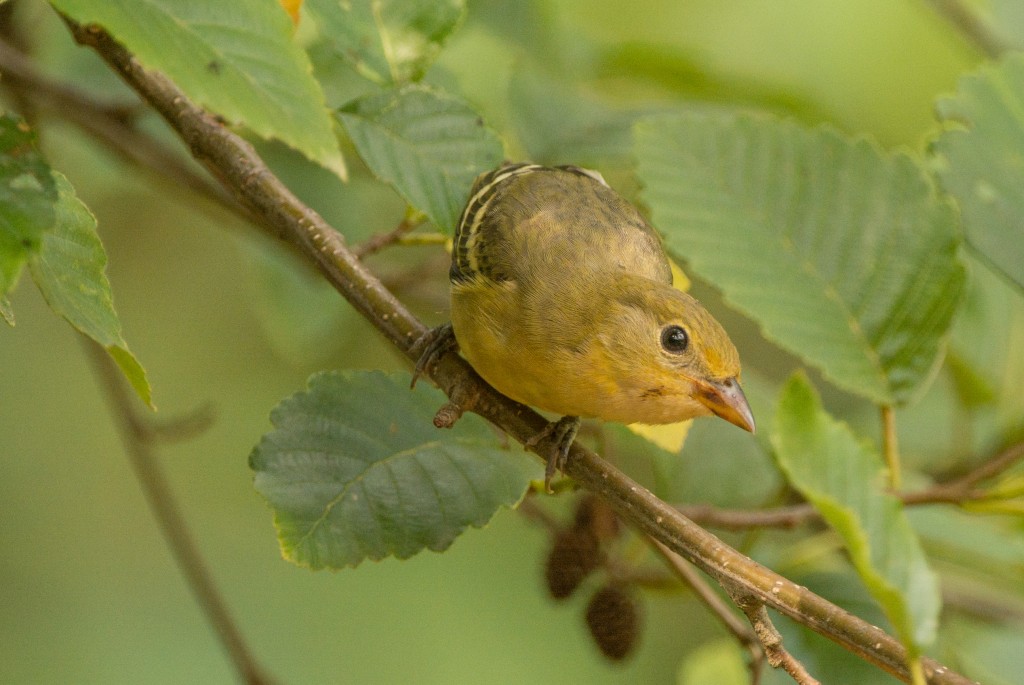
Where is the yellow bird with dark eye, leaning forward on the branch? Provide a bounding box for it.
[419,164,754,489]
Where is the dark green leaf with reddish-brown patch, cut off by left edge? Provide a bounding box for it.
[0,115,57,296]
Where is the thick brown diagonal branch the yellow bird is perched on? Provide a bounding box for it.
[69,17,971,685]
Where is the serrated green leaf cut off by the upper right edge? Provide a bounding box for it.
[934,53,1024,289]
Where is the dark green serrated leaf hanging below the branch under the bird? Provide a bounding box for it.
[250,372,539,569]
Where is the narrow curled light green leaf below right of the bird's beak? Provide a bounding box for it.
[772,373,940,656]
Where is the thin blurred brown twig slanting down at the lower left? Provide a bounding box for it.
[83,339,273,685]
